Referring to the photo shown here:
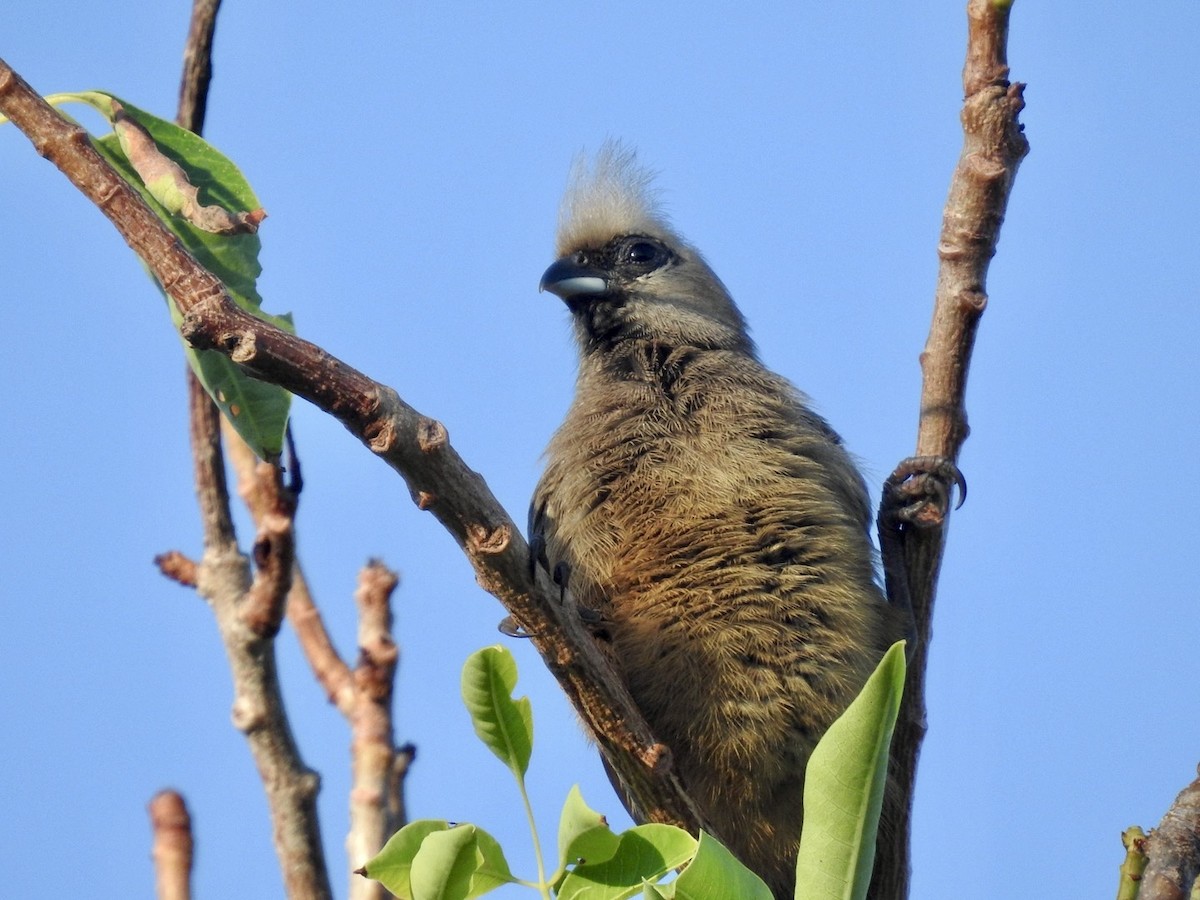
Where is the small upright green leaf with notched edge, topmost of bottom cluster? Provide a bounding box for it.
[462,646,533,782]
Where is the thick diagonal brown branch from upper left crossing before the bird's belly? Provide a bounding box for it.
[0,52,702,832]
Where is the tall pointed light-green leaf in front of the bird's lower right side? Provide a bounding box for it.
[796,641,905,900]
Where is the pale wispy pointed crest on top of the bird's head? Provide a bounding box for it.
[557,140,671,257]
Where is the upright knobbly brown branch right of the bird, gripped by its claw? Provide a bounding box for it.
[875,0,1028,898]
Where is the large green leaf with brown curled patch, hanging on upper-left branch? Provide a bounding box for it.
[48,91,295,458]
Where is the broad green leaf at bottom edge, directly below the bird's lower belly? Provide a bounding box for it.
[558,823,696,900]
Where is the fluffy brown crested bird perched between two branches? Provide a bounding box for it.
[529,142,905,898]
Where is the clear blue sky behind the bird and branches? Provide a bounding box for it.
[0,0,1200,899]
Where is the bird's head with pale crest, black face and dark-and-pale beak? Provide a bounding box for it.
[540,143,754,354]
